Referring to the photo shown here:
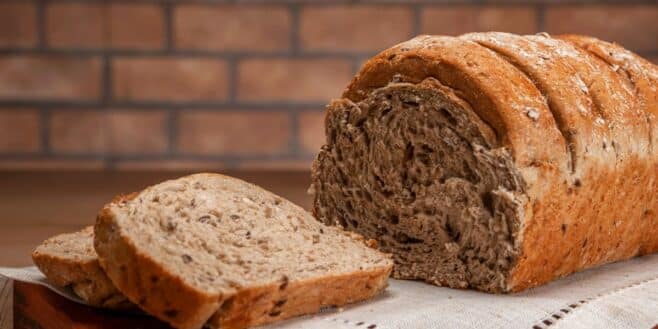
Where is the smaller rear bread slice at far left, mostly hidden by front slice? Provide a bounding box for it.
[32,226,138,310]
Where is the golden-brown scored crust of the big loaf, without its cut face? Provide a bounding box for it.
[316,33,658,291]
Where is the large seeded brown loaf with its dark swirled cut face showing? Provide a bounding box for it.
[310,32,658,292]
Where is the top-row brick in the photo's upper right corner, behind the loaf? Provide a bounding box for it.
[546,5,658,51]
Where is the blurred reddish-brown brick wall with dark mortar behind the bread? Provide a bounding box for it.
[0,0,658,170]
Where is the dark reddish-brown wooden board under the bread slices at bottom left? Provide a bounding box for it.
[13,281,171,329]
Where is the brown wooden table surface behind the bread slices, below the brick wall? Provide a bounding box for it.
[0,171,310,329]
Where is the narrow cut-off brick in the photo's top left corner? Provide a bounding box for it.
[0,3,37,47]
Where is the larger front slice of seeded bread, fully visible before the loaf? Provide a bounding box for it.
[94,174,392,329]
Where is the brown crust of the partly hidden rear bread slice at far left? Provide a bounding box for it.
[32,226,137,311]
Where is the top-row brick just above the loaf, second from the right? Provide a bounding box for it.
[421,6,537,35]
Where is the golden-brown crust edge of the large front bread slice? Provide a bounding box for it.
[94,174,392,329]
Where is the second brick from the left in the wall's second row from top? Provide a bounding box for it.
[112,57,228,101]
